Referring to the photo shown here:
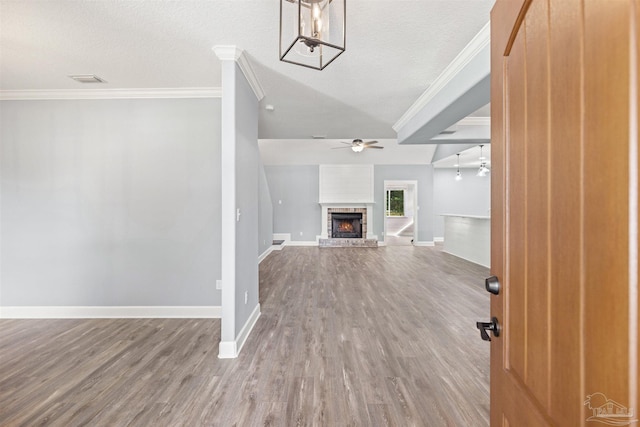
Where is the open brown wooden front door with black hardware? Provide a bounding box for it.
[491,0,640,427]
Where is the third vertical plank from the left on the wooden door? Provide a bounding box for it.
[549,0,585,426]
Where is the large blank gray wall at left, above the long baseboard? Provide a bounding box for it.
[0,99,220,306]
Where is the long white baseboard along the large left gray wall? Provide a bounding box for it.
[0,305,222,319]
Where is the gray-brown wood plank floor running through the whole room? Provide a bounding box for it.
[0,246,489,427]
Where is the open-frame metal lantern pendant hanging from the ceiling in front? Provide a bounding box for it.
[280,0,346,70]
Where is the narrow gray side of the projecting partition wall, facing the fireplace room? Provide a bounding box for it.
[233,64,260,336]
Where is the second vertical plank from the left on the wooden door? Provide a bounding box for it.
[524,2,550,410]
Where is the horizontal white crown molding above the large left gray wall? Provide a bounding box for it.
[0,87,222,101]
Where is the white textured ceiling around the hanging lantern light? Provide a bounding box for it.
[0,0,493,139]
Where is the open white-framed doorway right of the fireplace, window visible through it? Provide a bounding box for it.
[384,181,418,246]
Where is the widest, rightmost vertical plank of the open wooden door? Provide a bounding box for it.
[583,0,638,409]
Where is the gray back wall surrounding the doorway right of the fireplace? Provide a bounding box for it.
[373,165,434,242]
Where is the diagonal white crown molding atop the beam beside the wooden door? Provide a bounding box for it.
[393,22,491,132]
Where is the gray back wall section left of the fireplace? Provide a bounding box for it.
[264,165,322,241]
